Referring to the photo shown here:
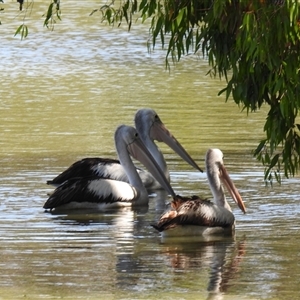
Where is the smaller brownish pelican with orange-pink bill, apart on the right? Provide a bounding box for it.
[152,149,246,237]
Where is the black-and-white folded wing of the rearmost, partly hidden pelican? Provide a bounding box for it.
[47,157,128,185]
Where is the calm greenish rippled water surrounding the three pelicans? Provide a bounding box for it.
[0,1,300,299]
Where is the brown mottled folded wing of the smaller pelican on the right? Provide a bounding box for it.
[152,196,234,232]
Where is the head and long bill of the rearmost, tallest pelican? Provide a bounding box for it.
[135,108,203,172]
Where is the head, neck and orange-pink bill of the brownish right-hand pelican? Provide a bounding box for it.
[205,149,246,213]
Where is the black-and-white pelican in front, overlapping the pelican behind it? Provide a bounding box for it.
[44,125,175,210]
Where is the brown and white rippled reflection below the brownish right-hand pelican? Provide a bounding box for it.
[160,237,246,300]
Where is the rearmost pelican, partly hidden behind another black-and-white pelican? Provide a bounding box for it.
[47,108,203,191]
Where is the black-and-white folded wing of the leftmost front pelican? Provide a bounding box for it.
[44,176,138,209]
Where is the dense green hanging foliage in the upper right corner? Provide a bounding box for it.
[100,0,300,181]
